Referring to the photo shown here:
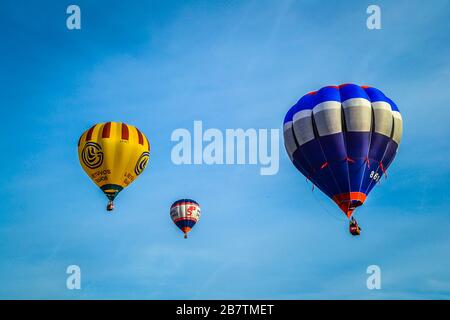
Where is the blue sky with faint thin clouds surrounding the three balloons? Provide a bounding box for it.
[0,0,450,299]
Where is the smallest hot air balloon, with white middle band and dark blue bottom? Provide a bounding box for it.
[170,199,200,239]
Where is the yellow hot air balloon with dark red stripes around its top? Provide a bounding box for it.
[78,122,150,211]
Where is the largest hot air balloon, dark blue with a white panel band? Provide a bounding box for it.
[283,84,403,235]
